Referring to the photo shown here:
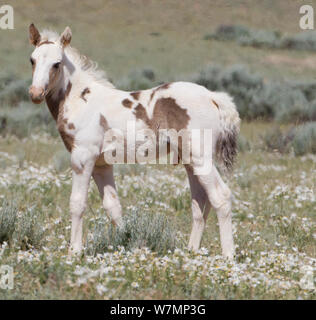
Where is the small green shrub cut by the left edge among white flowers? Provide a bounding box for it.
[0,201,17,243]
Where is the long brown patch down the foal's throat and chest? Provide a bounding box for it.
[46,82,75,152]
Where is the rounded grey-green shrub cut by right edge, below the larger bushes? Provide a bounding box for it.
[292,122,316,156]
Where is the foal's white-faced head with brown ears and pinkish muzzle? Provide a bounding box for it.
[29,23,71,103]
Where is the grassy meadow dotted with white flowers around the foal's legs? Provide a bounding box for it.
[0,123,316,299]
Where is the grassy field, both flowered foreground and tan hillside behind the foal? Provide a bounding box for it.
[0,0,316,299]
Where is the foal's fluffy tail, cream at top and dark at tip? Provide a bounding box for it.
[212,92,240,171]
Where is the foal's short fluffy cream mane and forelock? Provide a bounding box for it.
[41,29,114,88]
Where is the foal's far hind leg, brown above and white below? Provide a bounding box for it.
[185,165,211,250]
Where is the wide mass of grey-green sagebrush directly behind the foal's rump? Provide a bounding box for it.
[189,65,316,123]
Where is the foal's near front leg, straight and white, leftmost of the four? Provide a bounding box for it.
[70,153,95,253]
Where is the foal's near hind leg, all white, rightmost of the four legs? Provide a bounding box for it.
[193,165,234,259]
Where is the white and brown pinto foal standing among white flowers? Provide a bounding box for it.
[29,24,240,258]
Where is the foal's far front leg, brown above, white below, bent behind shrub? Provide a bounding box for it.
[92,165,122,226]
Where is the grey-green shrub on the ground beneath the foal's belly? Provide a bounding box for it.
[87,210,176,255]
